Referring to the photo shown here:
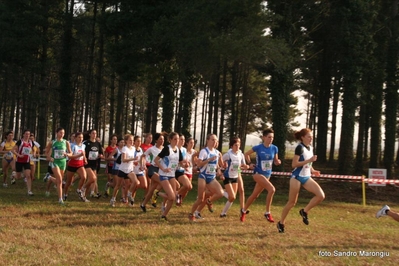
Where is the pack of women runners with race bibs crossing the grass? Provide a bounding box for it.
[0,128,324,233]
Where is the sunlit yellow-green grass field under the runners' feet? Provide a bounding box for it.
[0,167,399,265]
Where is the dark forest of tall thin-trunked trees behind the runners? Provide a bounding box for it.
[0,0,399,177]
